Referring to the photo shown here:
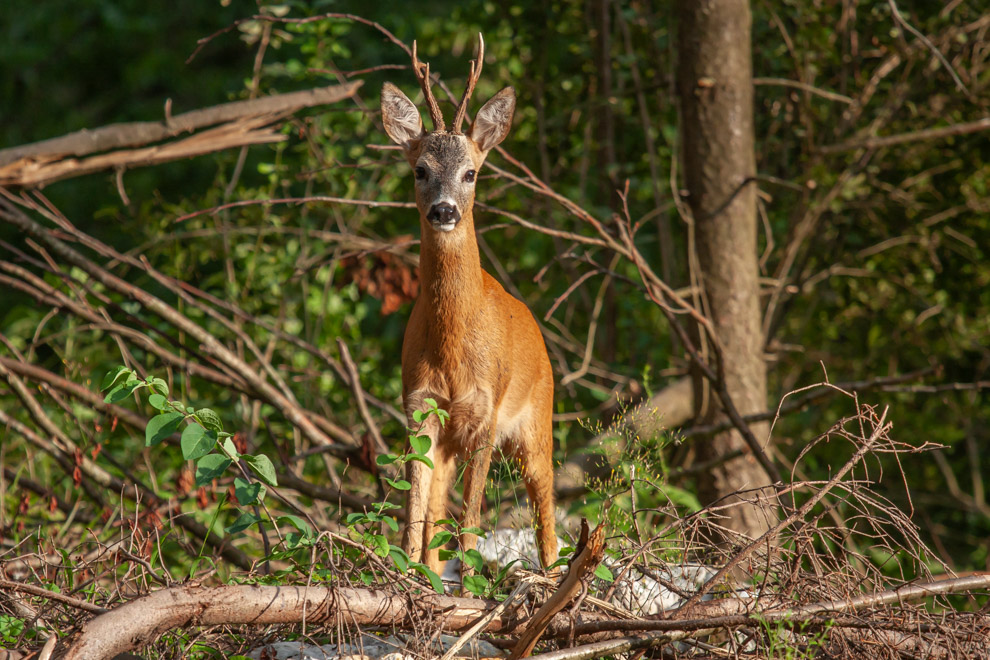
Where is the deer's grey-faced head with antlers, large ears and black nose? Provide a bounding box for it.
[382,34,516,233]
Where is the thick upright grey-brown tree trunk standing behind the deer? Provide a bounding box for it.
[677,0,770,534]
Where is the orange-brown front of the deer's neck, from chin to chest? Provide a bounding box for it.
[419,213,484,361]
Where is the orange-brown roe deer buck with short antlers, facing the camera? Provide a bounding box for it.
[381,34,557,577]
